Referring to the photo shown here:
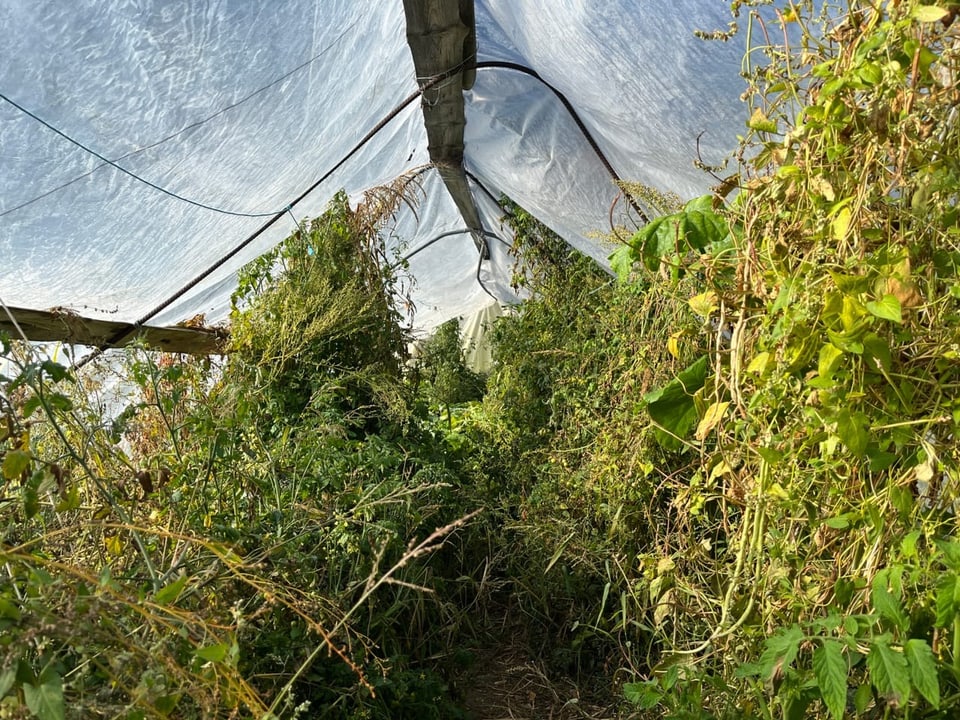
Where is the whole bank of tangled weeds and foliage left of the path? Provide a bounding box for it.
[0,186,479,720]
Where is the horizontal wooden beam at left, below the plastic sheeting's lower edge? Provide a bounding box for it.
[0,307,228,355]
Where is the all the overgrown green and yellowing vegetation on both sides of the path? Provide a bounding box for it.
[0,0,960,720]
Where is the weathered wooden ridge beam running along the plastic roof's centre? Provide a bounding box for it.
[403,0,488,257]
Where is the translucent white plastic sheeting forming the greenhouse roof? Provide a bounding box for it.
[0,0,743,336]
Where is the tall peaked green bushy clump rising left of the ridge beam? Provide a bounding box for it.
[229,187,407,429]
